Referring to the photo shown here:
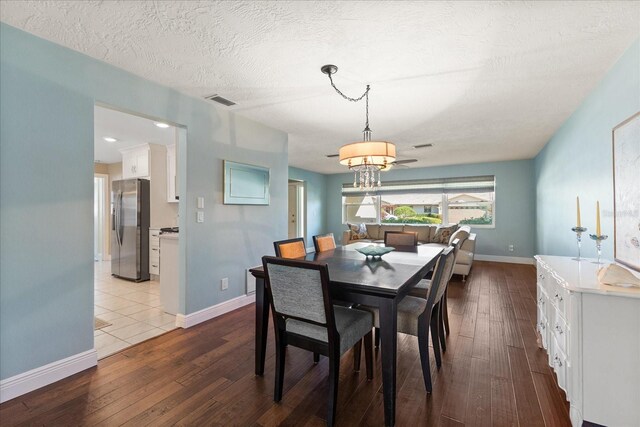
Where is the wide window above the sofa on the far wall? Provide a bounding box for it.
[342,176,495,228]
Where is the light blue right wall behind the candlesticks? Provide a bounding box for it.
[535,40,640,259]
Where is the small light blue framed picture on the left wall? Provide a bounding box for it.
[223,160,270,205]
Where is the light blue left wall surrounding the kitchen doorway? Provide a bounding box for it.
[0,24,288,379]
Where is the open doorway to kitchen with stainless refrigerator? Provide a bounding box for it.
[93,104,187,360]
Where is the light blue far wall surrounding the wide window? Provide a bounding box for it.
[327,160,535,257]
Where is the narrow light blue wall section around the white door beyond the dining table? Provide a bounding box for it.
[289,167,327,244]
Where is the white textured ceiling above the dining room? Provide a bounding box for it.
[0,1,640,173]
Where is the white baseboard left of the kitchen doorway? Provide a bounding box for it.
[0,349,98,403]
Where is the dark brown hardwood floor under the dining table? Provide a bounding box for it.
[0,261,570,426]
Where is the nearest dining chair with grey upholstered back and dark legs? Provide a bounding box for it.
[262,256,373,426]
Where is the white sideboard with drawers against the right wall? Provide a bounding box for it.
[535,255,640,426]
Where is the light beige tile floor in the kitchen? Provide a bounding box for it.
[94,261,176,359]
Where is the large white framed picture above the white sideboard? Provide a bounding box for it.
[613,112,640,271]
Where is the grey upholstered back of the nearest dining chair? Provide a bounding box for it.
[262,256,334,335]
